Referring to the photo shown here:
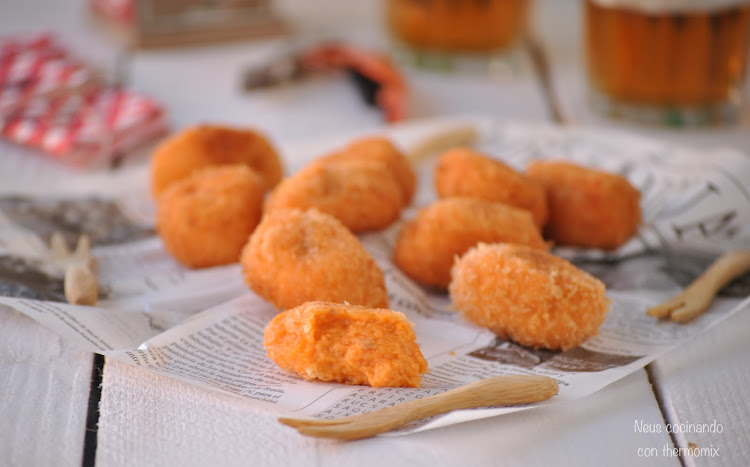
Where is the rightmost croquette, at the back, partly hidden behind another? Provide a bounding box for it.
[527,160,641,250]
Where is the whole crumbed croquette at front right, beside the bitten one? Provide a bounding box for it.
[449,244,609,350]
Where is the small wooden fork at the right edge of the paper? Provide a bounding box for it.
[646,250,750,323]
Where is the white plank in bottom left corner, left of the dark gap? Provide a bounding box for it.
[0,307,92,467]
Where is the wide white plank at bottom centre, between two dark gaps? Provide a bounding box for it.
[97,361,679,467]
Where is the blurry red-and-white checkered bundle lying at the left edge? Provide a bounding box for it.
[0,35,167,165]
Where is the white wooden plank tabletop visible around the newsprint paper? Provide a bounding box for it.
[0,0,750,466]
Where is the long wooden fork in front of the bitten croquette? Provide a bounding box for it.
[279,375,558,440]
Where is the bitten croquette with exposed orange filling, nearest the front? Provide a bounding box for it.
[263,302,427,387]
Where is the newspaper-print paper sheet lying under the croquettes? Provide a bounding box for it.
[0,119,750,434]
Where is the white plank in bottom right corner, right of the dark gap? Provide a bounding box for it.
[653,309,750,466]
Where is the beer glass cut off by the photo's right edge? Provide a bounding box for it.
[585,0,750,126]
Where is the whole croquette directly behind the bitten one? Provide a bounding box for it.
[241,209,388,310]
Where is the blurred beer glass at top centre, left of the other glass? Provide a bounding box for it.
[386,0,531,67]
